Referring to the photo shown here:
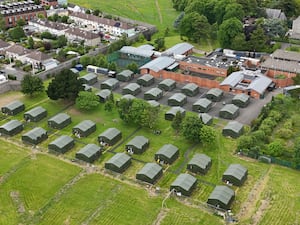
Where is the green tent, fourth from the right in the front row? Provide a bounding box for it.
[104,152,131,173]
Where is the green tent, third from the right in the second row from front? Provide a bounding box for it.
[154,144,179,164]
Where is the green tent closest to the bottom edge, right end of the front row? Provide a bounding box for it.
[207,185,235,210]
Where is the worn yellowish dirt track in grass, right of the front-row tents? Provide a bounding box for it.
[237,165,273,225]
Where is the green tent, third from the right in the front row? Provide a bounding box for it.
[136,163,163,184]
